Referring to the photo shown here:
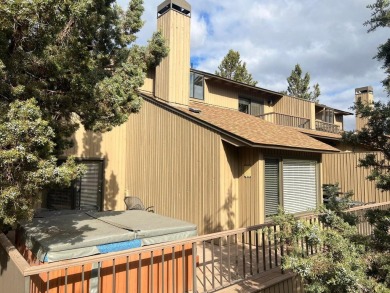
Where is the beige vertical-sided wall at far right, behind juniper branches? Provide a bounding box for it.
[322,153,390,203]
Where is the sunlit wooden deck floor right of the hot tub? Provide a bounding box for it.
[197,242,284,292]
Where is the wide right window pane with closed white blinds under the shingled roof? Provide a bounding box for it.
[283,160,317,213]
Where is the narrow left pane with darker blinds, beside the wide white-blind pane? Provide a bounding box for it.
[265,159,279,216]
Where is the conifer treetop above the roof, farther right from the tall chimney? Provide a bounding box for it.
[283,64,321,102]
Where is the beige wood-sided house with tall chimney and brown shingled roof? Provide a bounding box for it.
[51,0,368,234]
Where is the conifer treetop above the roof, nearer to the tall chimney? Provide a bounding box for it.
[215,50,257,86]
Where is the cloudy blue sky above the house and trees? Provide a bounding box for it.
[118,0,389,129]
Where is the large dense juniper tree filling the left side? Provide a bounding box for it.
[0,0,168,224]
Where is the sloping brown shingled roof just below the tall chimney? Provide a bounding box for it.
[143,94,339,153]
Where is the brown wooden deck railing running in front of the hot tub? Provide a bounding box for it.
[0,202,390,293]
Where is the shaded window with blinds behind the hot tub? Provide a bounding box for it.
[46,160,103,210]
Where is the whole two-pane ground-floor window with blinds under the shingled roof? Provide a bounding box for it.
[264,159,317,216]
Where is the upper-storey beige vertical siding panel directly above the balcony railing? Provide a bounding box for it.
[274,96,314,119]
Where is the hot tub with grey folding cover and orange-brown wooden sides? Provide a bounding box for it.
[16,211,197,293]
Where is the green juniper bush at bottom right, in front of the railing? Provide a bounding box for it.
[273,184,390,293]
